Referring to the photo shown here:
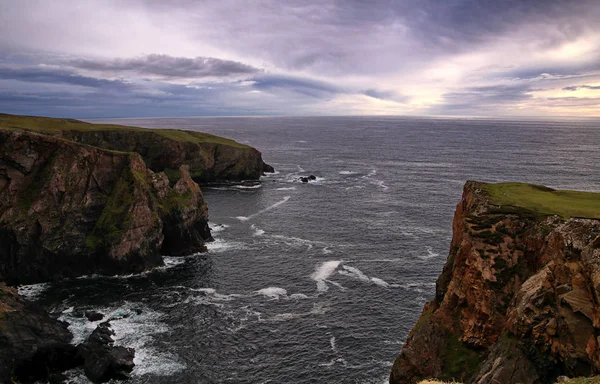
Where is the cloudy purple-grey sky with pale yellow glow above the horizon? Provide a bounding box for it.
[0,0,600,118]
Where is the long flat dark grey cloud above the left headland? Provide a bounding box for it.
[66,54,262,79]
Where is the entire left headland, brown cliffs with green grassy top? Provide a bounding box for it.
[0,115,266,284]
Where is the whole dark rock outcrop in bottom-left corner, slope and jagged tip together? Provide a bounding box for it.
[0,285,135,383]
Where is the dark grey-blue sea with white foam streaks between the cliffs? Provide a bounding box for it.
[19,117,600,383]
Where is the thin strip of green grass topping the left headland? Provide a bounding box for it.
[0,113,249,148]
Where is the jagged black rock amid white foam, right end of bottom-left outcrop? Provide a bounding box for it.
[77,322,135,383]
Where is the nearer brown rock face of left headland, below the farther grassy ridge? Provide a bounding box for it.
[0,129,210,284]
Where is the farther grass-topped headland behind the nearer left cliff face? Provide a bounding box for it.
[0,114,274,183]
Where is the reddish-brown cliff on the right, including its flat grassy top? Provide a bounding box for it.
[390,182,600,384]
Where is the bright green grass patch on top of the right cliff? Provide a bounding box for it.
[483,183,600,219]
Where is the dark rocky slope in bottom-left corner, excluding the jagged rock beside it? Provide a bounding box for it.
[0,284,81,383]
